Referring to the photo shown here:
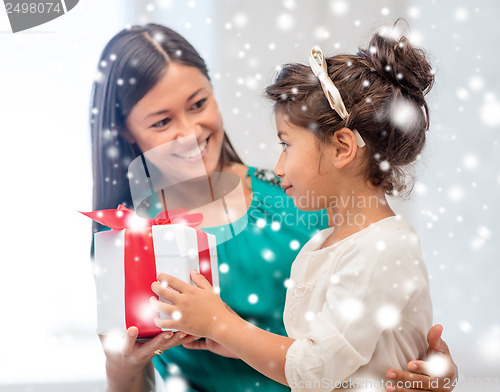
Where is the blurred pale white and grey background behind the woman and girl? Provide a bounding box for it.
[0,0,500,392]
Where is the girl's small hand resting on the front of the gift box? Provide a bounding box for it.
[150,270,230,337]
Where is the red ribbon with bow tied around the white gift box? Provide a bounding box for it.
[82,204,213,338]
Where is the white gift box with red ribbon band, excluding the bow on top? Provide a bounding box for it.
[94,224,219,338]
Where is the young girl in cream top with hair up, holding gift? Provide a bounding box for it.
[151,29,434,391]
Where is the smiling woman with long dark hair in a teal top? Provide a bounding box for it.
[91,24,455,392]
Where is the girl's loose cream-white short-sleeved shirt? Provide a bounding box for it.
[284,217,432,391]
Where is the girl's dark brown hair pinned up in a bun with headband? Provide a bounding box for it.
[265,25,434,194]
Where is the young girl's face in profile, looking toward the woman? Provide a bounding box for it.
[274,112,335,211]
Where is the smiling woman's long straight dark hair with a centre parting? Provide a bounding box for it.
[90,24,242,237]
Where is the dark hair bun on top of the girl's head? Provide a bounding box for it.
[360,33,434,101]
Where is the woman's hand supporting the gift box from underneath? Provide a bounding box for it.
[99,327,196,392]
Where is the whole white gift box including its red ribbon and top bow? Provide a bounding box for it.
[83,206,219,338]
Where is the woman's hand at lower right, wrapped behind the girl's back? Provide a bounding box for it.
[386,324,458,392]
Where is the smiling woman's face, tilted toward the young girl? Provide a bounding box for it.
[125,63,224,172]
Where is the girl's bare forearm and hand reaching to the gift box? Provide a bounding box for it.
[151,271,294,385]
